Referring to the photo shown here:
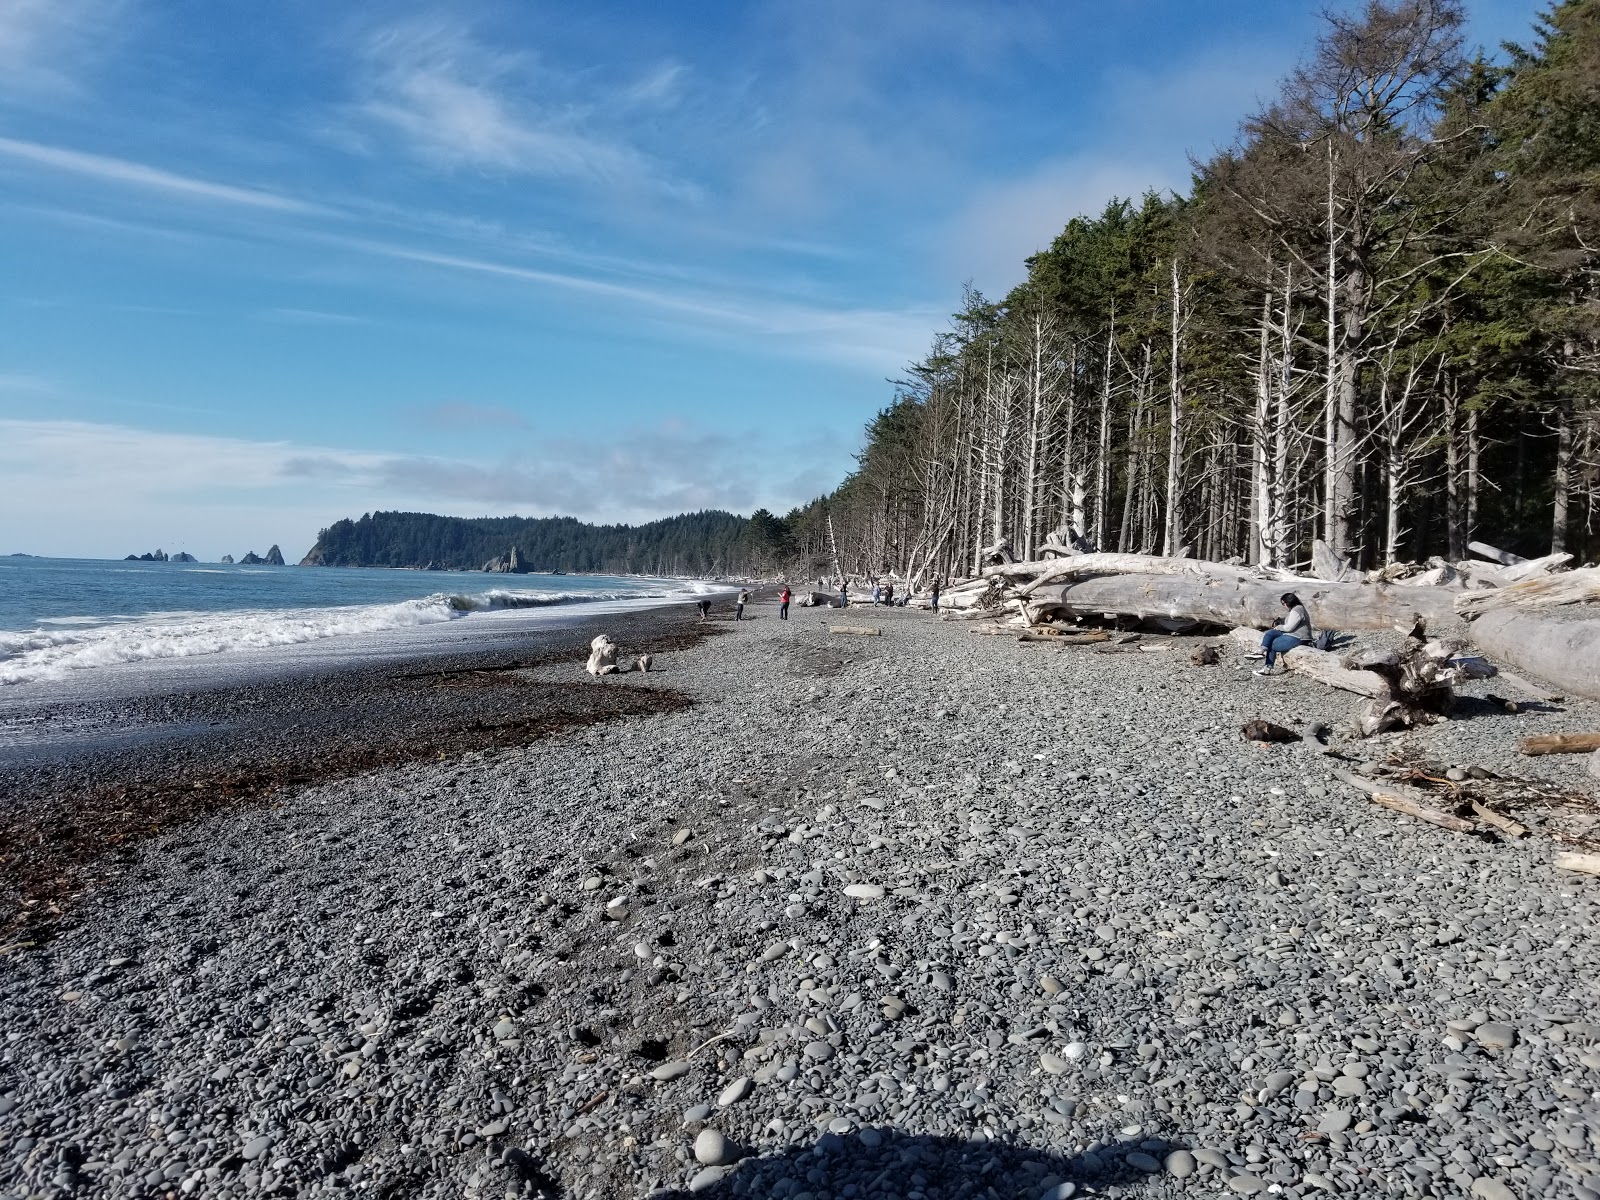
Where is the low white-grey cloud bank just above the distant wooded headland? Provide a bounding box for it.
[0,419,848,558]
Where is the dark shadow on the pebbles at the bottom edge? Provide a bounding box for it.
[653,1126,1182,1200]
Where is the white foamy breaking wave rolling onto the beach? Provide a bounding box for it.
[0,581,725,685]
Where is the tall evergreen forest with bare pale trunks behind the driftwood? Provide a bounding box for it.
[812,0,1600,578]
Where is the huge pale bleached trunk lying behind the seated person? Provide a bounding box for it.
[1026,579,1456,629]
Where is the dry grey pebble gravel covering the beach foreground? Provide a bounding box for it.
[0,603,1600,1200]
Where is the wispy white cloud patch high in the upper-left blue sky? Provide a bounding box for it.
[357,22,693,195]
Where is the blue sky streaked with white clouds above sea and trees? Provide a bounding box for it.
[0,0,1536,560]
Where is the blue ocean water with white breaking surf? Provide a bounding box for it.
[0,557,725,686]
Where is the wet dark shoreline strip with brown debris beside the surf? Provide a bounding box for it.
[0,602,732,936]
